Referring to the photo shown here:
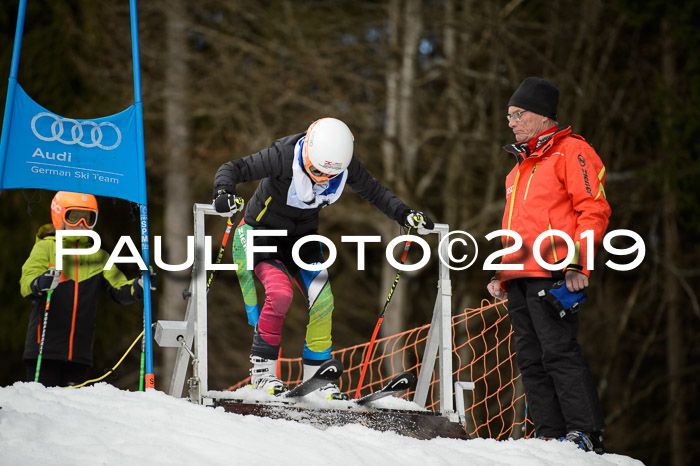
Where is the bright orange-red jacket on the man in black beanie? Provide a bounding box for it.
[495,127,611,289]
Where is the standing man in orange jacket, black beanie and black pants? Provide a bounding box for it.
[488,77,611,453]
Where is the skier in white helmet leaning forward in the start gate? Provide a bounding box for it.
[213,118,434,399]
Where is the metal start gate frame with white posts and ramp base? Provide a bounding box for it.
[155,204,476,438]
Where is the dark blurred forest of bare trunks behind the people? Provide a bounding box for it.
[0,0,700,465]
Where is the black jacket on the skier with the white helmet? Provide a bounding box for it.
[214,133,411,236]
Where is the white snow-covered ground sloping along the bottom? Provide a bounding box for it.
[0,383,642,466]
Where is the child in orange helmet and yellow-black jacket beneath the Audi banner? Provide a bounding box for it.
[20,191,155,386]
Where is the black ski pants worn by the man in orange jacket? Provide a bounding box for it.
[508,278,605,438]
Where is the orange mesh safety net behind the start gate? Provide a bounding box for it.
[228,300,533,440]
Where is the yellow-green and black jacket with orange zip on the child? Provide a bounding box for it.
[20,225,143,366]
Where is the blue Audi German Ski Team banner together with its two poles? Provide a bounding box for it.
[0,0,155,390]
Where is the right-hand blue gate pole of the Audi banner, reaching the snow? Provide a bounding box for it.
[129,0,155,390]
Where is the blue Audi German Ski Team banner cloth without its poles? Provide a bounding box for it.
[0,84,146,204]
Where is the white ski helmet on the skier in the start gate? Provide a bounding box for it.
[302,118,355,183]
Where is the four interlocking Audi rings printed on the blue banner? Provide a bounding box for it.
[32,112,122,150]
